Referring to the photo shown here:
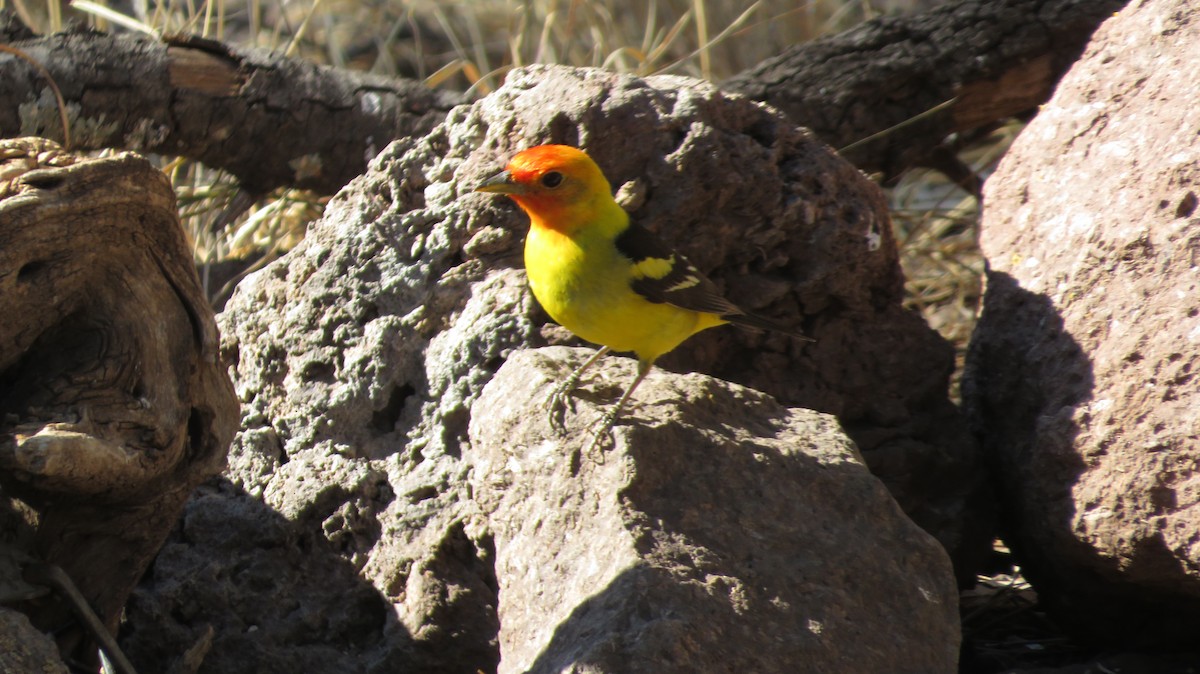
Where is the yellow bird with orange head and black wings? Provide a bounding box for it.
[475,145,811,452]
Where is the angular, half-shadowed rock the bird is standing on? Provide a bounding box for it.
[470,348,959,674]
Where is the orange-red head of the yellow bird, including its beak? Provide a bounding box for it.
[475,145,612,229]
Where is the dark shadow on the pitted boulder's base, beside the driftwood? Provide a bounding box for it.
[121,480,497,674]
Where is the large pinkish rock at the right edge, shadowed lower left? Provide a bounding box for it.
[965,0,1200,648]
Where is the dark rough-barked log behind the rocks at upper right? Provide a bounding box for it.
[722,0,1127,175]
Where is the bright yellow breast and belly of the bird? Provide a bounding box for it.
[524,225,722,362]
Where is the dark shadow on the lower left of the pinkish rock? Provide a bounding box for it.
[964,271,1200,646]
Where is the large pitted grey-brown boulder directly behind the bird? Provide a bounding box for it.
[124,67,988,674]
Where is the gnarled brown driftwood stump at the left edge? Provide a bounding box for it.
[0,139,238,661]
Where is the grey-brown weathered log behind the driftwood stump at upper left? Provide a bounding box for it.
[0,22,460,194]
